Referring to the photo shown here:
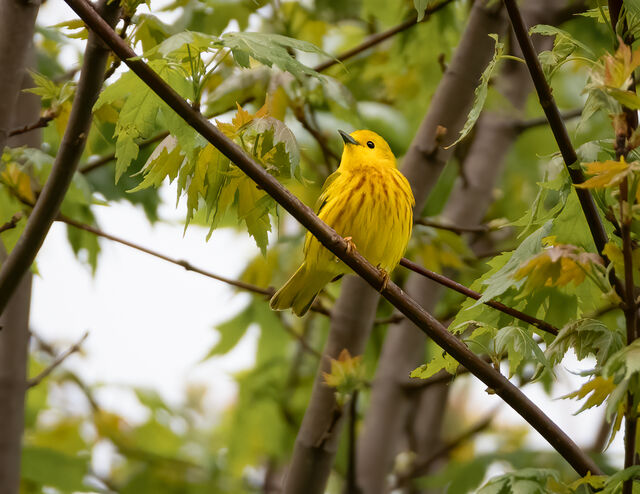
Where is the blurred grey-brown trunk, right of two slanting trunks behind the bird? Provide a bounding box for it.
[359,0,576,494]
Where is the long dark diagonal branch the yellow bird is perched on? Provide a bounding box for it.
[65,0,600,476]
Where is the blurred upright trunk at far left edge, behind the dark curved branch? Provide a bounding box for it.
[0,53,42,494]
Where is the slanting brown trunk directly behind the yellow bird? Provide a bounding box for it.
[285,1,505,494]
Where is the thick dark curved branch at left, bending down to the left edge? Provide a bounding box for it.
[0,0,119,314]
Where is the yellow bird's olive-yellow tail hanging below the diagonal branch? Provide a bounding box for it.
[269,262,333,317]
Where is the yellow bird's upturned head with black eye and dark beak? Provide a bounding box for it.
[338,130,396,168]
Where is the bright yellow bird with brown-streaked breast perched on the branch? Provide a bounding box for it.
[270,130,415,316]
